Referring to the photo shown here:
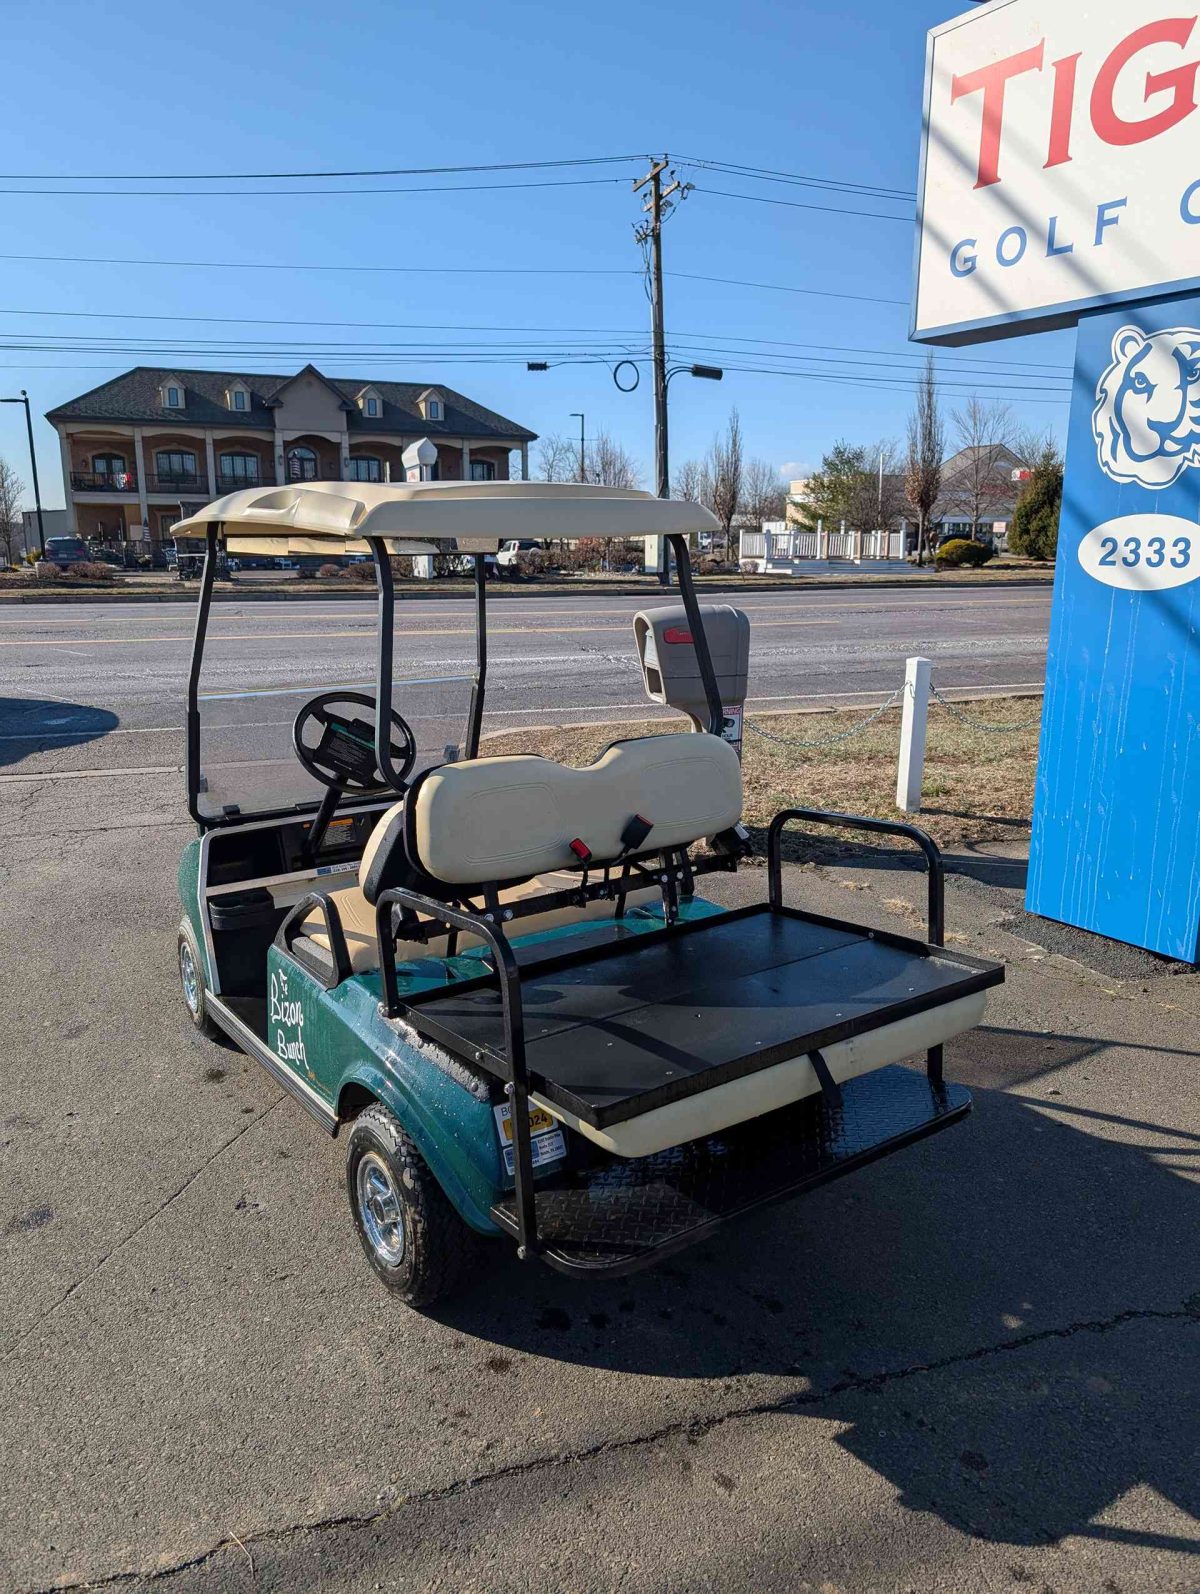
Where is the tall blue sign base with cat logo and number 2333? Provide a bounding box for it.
[1026,296,1200,963]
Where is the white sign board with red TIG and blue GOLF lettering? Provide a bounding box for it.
[913,0,1200,344]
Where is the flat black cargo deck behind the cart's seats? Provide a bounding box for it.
[406,904,1004,1134]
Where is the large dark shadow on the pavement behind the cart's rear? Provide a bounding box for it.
[427,1028,1200,1551]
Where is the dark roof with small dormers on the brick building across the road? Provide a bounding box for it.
[46,365,537,443]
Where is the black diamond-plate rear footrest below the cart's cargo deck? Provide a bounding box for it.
[492,1066,971,1274]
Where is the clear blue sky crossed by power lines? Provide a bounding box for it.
[0,0,1073,505]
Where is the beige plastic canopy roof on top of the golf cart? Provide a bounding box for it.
[172,481,719,553]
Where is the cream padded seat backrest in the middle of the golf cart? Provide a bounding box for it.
[359,732,741,901]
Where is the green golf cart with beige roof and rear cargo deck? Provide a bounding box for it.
[175,481,1004,1305]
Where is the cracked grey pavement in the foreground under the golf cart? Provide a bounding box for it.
[0,682,1200,1594]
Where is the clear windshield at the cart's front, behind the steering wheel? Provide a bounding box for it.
[198,598,475,819]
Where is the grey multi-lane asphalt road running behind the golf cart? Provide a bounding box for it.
[0,587,1050,802]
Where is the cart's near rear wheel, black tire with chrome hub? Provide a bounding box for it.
[346,1101,480,1307]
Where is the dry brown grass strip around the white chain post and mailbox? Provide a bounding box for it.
[481,698,1039,846]
